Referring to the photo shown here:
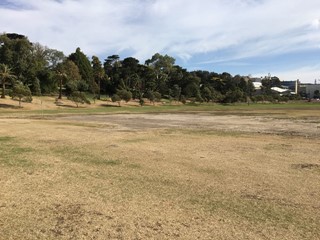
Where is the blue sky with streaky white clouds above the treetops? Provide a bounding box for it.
[0,0,320,82]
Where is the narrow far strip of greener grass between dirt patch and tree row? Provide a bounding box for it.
[0,102,320,118]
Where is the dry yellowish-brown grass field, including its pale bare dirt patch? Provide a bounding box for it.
[0,97,320,240]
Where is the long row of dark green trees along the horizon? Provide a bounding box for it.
[0,33,300,105]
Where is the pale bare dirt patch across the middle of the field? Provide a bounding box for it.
[61,113,320,137]
